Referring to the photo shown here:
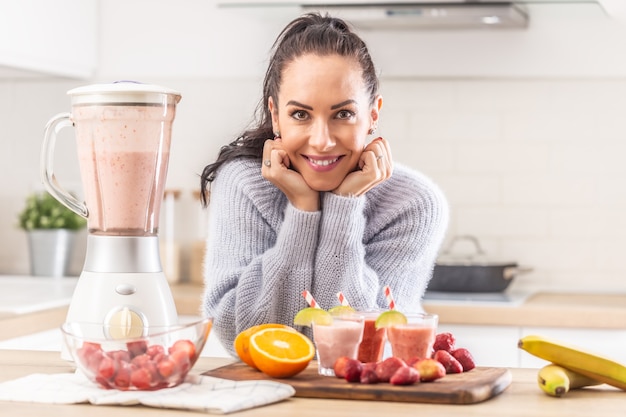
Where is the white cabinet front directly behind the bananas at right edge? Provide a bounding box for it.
[519,327,626,368]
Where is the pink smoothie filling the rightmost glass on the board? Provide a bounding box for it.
[387,324,435,361]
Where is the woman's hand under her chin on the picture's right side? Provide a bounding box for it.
[333,137,393,196]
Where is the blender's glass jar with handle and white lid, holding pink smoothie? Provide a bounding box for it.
[42,82,181,236]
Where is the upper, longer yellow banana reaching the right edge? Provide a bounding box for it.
[517,335,626,390]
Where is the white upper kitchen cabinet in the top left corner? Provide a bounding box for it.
[0,0,99,79]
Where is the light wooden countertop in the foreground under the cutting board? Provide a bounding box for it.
[0,350,626,417]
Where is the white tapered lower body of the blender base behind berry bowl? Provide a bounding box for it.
[61,271,178,360]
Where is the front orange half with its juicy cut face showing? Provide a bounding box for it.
[250,329,315,378]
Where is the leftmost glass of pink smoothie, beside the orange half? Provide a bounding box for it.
[313,314,364,376]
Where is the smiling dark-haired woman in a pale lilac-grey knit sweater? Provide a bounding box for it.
[201,14,448,353]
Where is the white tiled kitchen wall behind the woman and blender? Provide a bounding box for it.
[0,0,626,291]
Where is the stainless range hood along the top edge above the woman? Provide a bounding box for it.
[217,0,612,30]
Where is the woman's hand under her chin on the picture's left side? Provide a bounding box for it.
[261,138,320,211]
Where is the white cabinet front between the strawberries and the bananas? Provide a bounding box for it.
[437,324,520,368]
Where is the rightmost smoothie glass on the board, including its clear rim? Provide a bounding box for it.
[387,313,438,362]
